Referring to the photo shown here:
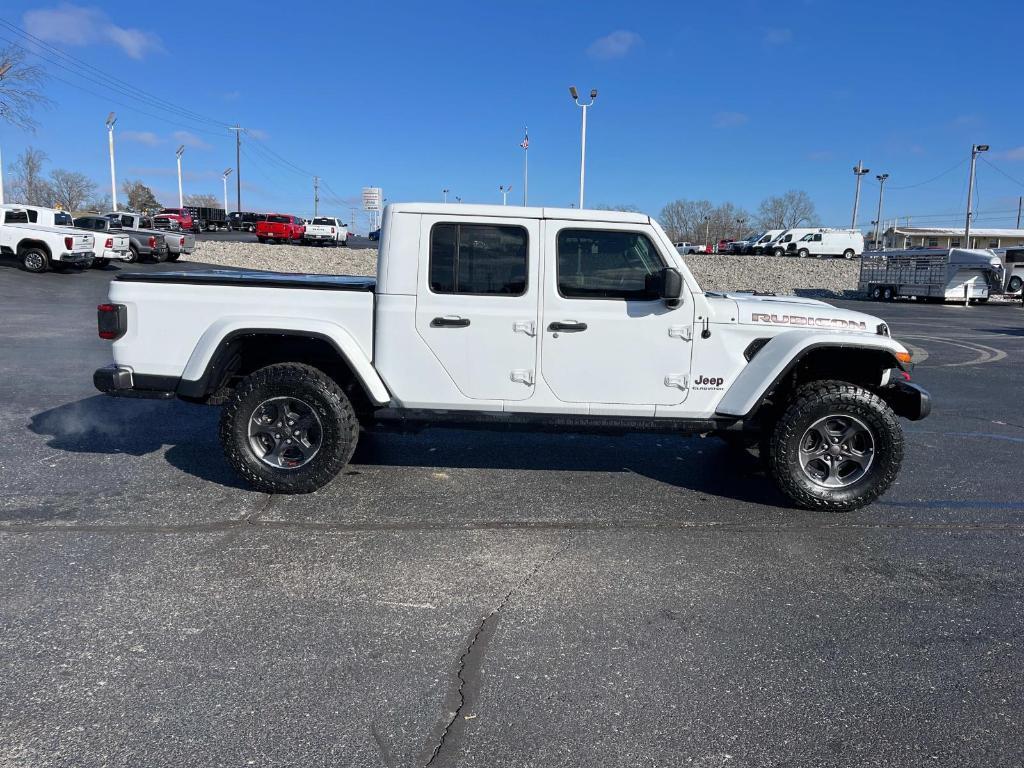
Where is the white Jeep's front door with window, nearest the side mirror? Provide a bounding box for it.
[541,221,693,406]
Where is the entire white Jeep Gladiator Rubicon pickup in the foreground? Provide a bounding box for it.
[93,204,931,511]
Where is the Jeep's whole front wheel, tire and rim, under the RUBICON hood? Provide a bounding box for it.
[768,381,903,512]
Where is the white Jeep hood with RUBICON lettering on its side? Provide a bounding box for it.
[710,293,885,334]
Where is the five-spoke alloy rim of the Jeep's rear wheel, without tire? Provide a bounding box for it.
[249,397,324,469]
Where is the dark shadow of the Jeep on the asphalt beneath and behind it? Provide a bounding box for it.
[29,395,785,506]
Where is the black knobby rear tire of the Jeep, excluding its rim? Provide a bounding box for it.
[220,362,359,494]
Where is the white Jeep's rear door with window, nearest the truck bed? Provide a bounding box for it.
[416,216,540,400]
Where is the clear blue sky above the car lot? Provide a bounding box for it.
[0,0,1024,228]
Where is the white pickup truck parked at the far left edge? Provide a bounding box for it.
[0,206,95,272]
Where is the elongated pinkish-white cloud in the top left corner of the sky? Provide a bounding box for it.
[22,3,163,59]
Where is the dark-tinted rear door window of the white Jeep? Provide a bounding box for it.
[430,223,529,296]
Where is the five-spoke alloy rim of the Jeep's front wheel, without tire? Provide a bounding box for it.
[800,414,874,488]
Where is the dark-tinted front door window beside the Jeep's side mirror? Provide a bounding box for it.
[558,229,665,301]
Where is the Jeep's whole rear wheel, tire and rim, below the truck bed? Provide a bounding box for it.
[220,362,359,494]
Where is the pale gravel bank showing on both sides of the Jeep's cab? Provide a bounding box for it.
[189,241,860,298]
